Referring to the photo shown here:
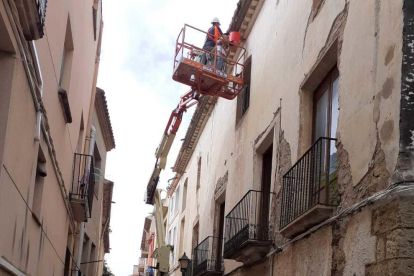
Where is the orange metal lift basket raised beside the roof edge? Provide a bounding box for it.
[173,24,246,100]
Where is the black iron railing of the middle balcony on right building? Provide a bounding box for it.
[224,190,275,258]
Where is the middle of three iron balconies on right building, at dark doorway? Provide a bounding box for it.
[224,190,275,263]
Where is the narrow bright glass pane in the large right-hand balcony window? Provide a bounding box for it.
[329,77,339,174]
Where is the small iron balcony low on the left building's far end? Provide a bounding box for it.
[69,153,95,222]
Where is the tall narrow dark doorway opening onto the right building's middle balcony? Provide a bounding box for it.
[258,144,273,240]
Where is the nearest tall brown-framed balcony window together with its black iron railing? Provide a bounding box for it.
[280,67,339,230]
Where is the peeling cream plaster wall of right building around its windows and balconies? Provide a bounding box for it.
[167,0,403,275]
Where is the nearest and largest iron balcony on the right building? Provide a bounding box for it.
[280,137,338,238]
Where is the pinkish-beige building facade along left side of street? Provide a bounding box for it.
[0,0,115,276]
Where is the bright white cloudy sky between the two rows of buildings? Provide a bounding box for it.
[98,0,238,276]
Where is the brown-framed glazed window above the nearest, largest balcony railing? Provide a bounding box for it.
[312,67,339,173]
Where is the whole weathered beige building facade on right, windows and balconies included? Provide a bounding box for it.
[166,0,414,276]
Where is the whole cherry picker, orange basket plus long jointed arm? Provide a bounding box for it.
[145,25,246,275]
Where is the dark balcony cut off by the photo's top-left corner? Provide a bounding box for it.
[14,0,47,40]
